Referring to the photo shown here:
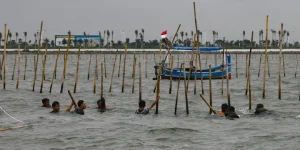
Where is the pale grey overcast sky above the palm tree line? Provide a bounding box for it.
[0,0,300,42]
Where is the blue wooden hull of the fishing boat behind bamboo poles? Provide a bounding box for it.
[153,56,231,80]
